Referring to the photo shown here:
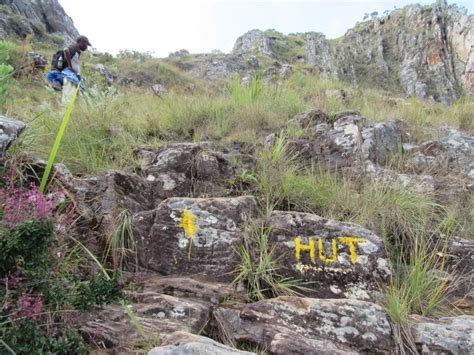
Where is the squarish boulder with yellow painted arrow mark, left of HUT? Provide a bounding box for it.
[133,196,257,280]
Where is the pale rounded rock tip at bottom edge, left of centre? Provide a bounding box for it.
[148,332,254,355]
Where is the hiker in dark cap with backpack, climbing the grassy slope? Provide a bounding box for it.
[46,36,91,104]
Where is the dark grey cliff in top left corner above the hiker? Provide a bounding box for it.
[0,0,79,42]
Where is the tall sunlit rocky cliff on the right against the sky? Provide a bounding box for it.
[233,1,474,103]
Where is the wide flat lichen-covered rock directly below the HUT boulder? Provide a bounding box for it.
[214,297,393,355]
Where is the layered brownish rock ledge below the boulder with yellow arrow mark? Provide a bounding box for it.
[81,277,237,350]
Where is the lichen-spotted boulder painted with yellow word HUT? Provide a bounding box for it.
[266,211,390,300]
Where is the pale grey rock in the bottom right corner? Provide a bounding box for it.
[411,316,474,355]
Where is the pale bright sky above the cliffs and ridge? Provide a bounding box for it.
[59,0,474,57]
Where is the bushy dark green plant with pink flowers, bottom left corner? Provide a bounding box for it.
[0,170,121,354]
